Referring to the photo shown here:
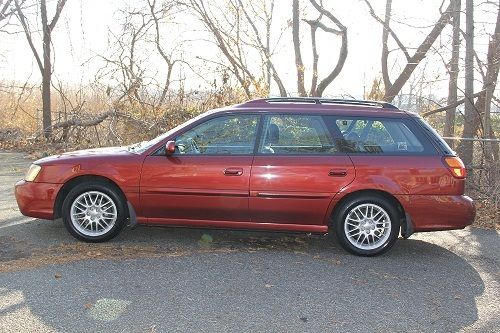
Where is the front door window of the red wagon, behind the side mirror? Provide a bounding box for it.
[175,114,259,155]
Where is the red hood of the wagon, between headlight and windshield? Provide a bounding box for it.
[35,147,135,164]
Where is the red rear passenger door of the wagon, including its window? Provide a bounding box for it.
[250,114,354,225]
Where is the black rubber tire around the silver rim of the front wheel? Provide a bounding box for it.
[61,182,127,243]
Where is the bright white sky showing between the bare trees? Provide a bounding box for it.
[0,0,495,98]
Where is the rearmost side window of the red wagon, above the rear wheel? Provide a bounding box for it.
[328,117,432,154]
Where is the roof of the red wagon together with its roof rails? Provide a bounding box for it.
[223,97,408,117]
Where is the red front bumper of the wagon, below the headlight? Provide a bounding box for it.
[15,180,62,220]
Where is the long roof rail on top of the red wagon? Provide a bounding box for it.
[242,97,398,110]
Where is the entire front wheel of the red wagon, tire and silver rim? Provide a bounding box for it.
[61,182,127,243]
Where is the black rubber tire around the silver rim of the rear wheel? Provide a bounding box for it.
[333,195,400,257]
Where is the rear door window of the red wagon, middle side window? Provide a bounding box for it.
[259,115,337,155]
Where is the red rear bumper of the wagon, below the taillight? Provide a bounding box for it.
[399,195,476,232]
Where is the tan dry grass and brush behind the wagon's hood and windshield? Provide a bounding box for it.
[0,83,250,157]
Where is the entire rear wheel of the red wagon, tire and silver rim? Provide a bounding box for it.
[333,194,400,257]
